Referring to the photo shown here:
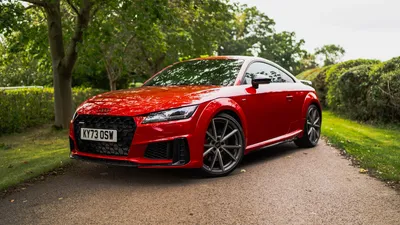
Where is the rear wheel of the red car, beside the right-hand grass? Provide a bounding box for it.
[294,105,321,148]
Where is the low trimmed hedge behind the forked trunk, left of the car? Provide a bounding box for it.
[0,88,104,135]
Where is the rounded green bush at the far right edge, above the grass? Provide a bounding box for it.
[368,57,400,122]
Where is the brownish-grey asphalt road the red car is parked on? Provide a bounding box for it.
[0,141,400,225]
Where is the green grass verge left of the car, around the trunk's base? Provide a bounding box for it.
[0,125,69,190]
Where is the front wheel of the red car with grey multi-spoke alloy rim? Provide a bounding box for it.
[201,113,245,177]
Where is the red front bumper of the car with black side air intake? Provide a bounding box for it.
[69,110,205,168]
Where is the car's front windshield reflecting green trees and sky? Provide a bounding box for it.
[144,59,243,86]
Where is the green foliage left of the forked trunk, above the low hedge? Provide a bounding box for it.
[0,2,52,86]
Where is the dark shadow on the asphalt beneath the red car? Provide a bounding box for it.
[73,143,299,186]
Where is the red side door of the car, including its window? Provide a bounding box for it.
[238,62,290,145]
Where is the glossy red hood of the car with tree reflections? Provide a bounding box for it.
[78,86,220,116]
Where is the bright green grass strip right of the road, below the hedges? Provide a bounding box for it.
[322,111,400,182]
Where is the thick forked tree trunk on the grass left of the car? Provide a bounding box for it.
[11,0,98,128]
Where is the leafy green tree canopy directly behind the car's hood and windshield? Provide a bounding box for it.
[83,0,232,90]
